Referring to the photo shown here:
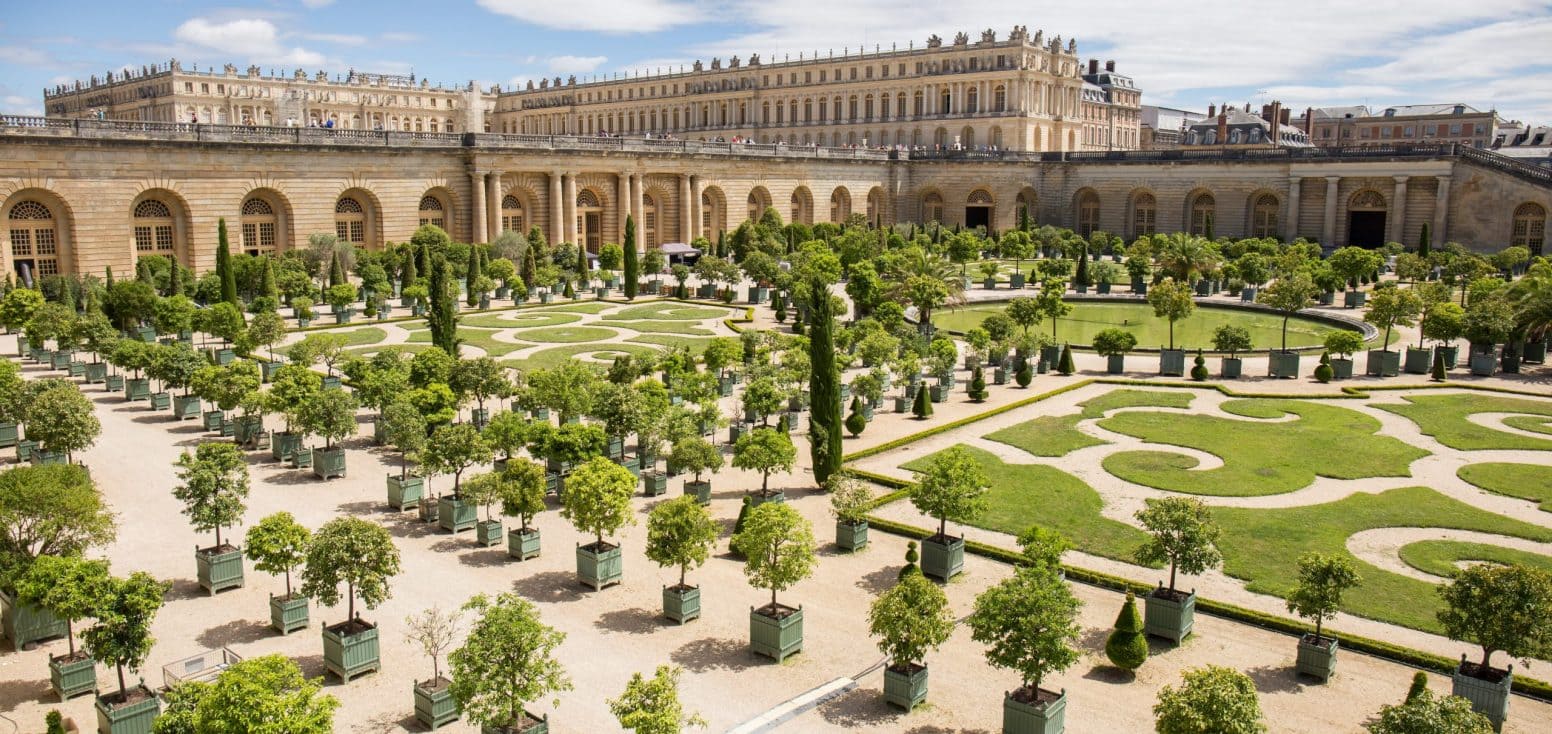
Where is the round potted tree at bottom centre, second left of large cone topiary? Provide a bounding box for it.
[868,574,954,711]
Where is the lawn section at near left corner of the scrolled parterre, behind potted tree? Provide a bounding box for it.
[900,447,1147,563]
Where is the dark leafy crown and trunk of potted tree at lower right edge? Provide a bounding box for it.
[1437,563,1552,680]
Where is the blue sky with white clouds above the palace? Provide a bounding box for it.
[0,0,1552,124]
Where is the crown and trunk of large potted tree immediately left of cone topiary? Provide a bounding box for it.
[968,566,1080,705]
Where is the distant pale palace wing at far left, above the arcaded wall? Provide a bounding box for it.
[43,59,495,132]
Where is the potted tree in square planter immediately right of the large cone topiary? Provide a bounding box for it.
[1136,497,1223,644]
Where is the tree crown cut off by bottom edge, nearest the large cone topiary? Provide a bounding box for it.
[1153,666,1266,734]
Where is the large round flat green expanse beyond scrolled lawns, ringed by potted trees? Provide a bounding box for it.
[933,301,1359,349]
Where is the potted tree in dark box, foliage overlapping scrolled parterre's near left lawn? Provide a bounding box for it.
[911,445,990,580]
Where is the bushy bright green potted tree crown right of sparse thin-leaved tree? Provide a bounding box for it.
[447,593,571,734]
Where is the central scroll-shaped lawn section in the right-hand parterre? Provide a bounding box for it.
[1099,399,1428,497]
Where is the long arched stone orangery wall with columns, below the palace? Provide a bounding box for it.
[0,116,1552,275]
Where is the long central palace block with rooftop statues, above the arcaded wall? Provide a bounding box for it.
[490,26,1141,151]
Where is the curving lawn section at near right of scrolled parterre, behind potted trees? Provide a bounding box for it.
[1212,487,1552,632]
